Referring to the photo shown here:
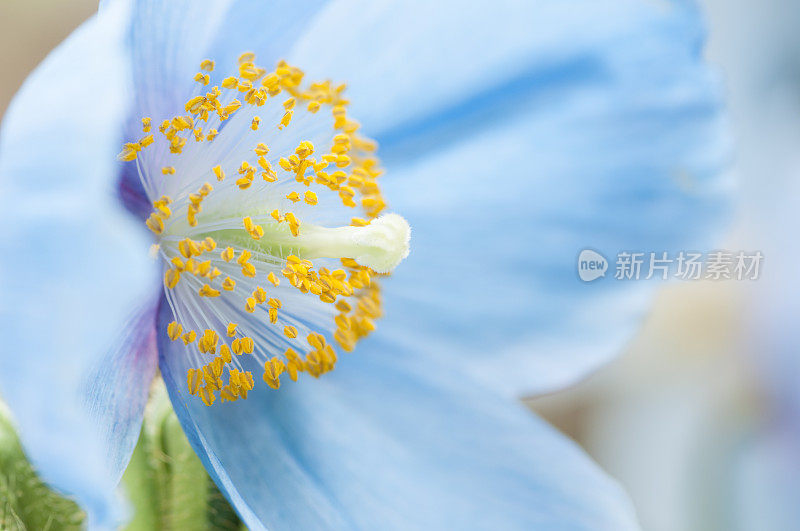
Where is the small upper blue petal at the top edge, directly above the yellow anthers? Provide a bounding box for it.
[130,0,327,126]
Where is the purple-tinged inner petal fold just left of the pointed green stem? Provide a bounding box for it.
[84,305,158,479]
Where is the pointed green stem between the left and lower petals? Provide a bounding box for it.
[123,383,242,531]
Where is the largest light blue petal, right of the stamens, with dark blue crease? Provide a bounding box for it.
[291,0,728,393]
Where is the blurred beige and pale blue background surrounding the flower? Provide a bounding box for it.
[0,0,800,531]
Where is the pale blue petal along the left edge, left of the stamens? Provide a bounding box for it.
[0,2,156,527]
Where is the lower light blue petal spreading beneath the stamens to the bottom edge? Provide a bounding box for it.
[158,305,636,531]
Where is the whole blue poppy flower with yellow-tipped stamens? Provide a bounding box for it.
[0,0,725,529]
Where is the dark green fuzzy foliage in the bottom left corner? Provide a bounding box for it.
[0,403,85,531]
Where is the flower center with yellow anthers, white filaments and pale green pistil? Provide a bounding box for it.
[119,53,410,406]
